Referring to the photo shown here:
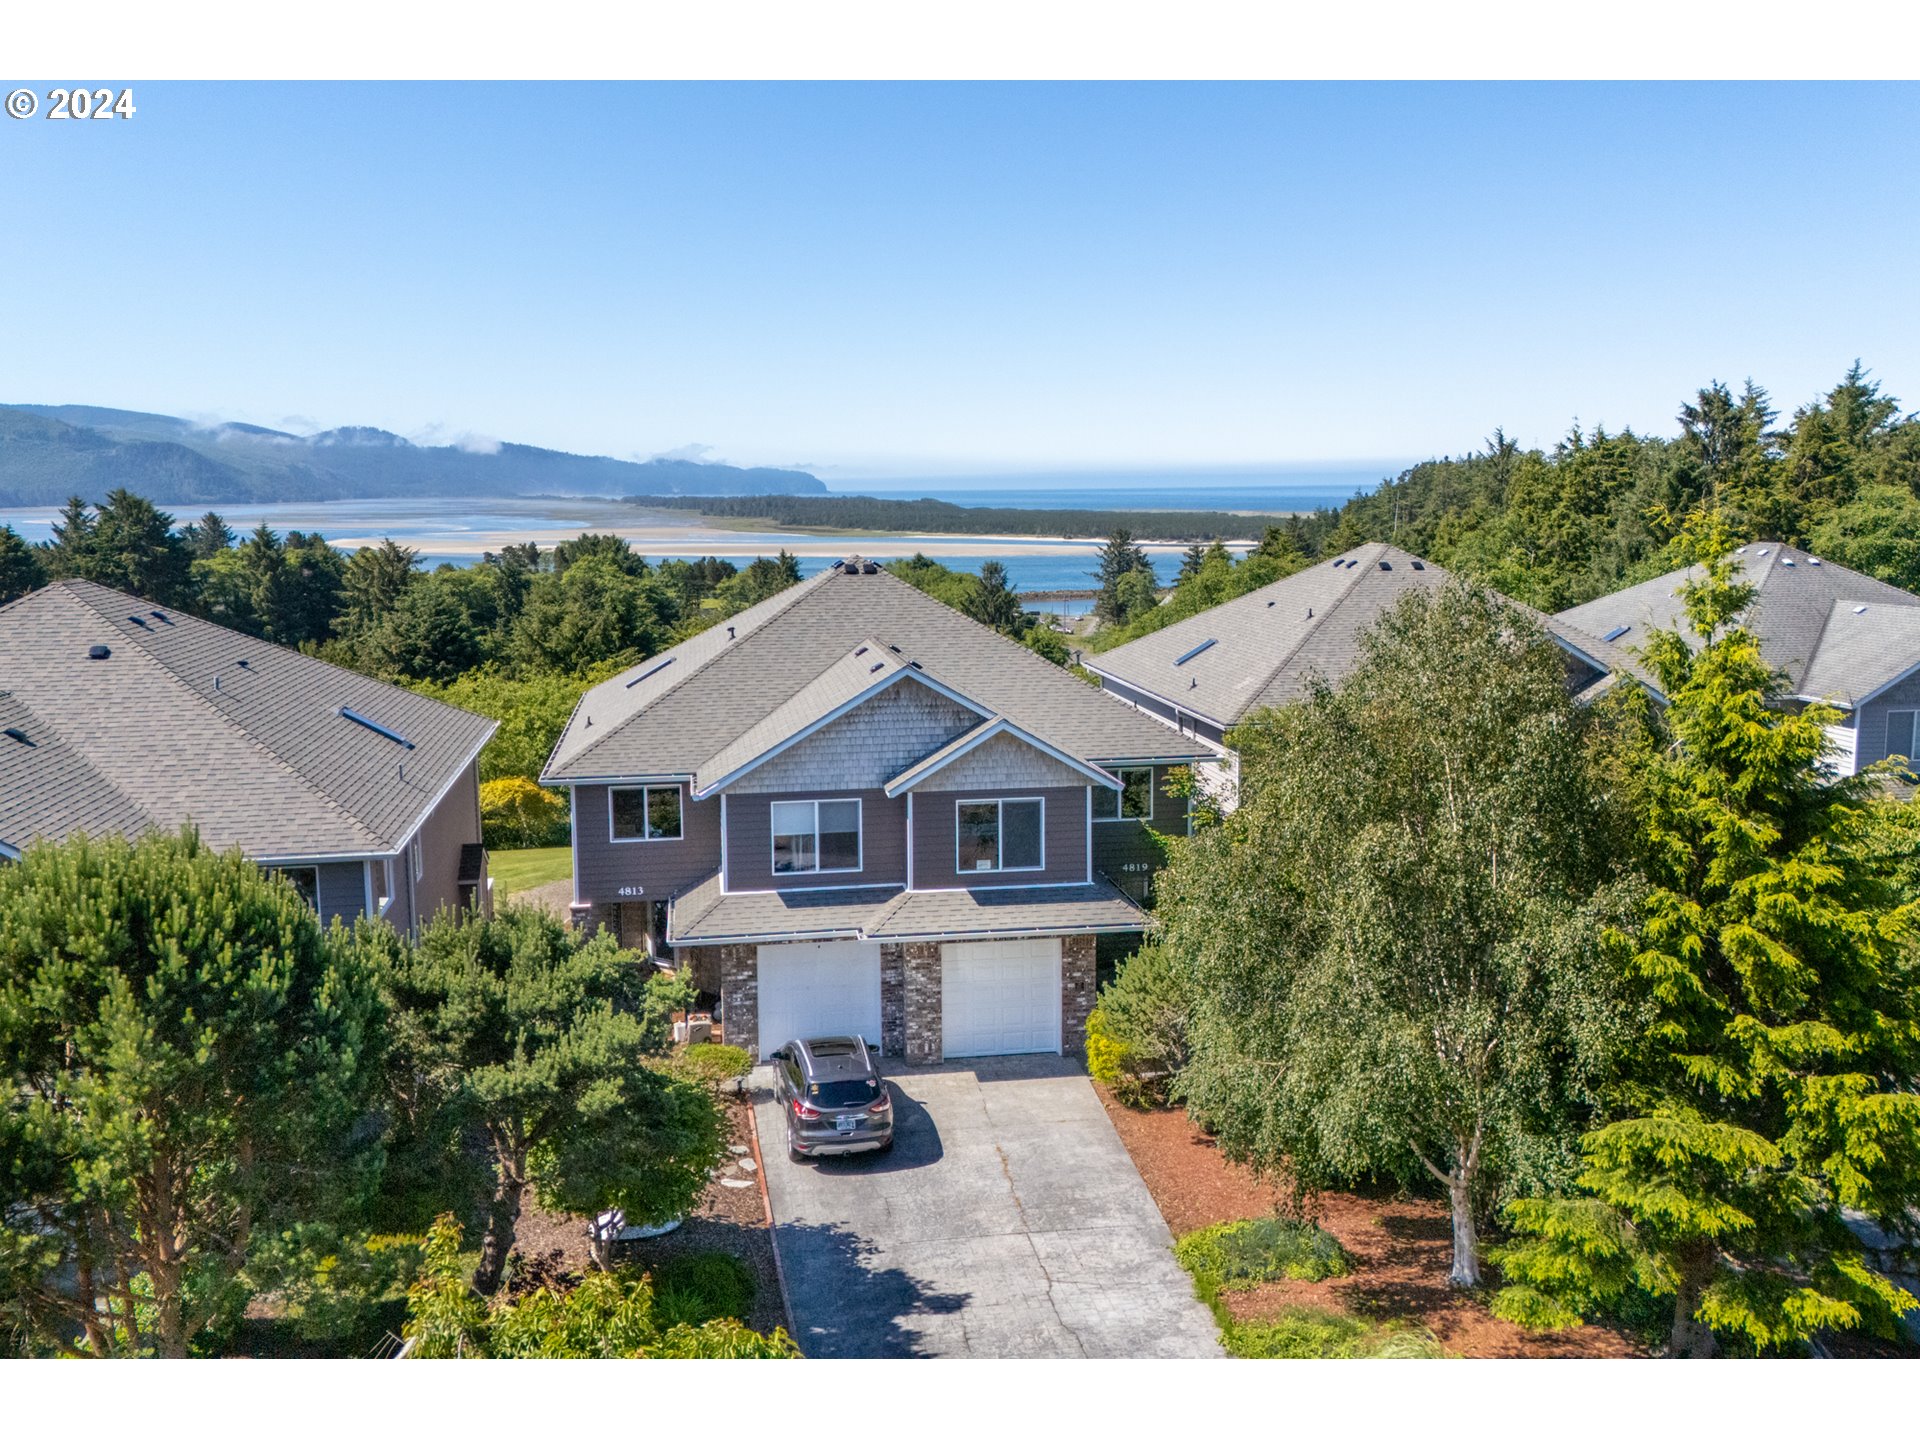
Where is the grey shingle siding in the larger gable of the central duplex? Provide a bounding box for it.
[728,676,981,804]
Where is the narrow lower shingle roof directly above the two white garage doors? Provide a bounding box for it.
[666,874,1146,945]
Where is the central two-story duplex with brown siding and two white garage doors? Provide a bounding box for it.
[541,557,1206,1062]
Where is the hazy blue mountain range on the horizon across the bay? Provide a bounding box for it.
[0,405,828,507]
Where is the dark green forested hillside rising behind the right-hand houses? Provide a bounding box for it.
[1092,363,1920,649]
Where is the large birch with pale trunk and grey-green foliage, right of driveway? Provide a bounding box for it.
[1160,586,1624,1286]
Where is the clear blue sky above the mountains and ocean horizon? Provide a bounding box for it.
[0,83,1920,476]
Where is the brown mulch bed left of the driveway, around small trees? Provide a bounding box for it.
[515,1096,787,1332]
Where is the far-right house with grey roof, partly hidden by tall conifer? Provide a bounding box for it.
[1555,541,1920,776]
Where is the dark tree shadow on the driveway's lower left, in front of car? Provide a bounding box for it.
[776,1223,972,1359]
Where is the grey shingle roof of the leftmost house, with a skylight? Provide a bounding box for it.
[0,580,495,858]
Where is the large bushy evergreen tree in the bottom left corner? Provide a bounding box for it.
[0,833,380,1357]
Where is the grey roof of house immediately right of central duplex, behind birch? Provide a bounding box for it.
[1085,543,1638,726]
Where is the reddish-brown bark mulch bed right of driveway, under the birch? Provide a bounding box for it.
[1094,1087,1647,1359]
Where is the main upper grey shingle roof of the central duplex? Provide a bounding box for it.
[541,563,1196,789]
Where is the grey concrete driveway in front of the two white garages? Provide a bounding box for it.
[755,1056,1221,1357]
